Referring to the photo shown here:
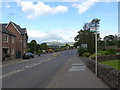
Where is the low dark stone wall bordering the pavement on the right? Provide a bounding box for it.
[87,59,120,88]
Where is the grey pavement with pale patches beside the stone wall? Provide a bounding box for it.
[48,55,109,88]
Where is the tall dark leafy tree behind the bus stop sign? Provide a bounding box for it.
[74,18,100,53]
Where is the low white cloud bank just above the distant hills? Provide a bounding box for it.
[27,29,78,43]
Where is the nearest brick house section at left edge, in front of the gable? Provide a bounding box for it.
[0,24,16,60]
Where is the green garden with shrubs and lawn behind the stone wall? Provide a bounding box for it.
[78,47,120,70]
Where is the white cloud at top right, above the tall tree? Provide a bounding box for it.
[72,0,99,14]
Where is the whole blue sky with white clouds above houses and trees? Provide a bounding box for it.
[0,0,118,43]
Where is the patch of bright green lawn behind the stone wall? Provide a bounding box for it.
[100,59,120,70]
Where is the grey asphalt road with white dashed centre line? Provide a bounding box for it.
[2,50,76,88]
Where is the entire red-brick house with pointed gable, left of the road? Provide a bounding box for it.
[2,21,28,59]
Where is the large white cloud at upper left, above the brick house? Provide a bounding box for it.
[17,1,68,18]
